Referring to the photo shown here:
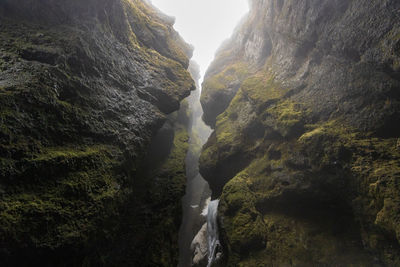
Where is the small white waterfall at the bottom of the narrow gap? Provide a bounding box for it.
[207,199,221,267]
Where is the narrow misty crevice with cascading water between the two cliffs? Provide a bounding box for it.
[178,62,221,267]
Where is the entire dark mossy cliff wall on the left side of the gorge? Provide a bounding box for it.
[0,0,194,266]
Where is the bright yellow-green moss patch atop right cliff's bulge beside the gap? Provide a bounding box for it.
[201,74,310,179]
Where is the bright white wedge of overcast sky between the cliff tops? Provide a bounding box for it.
[151,0,248,80]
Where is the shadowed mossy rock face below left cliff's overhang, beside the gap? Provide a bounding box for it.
[114,121,189,266]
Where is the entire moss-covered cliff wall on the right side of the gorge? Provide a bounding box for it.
[200,0,400,266]
